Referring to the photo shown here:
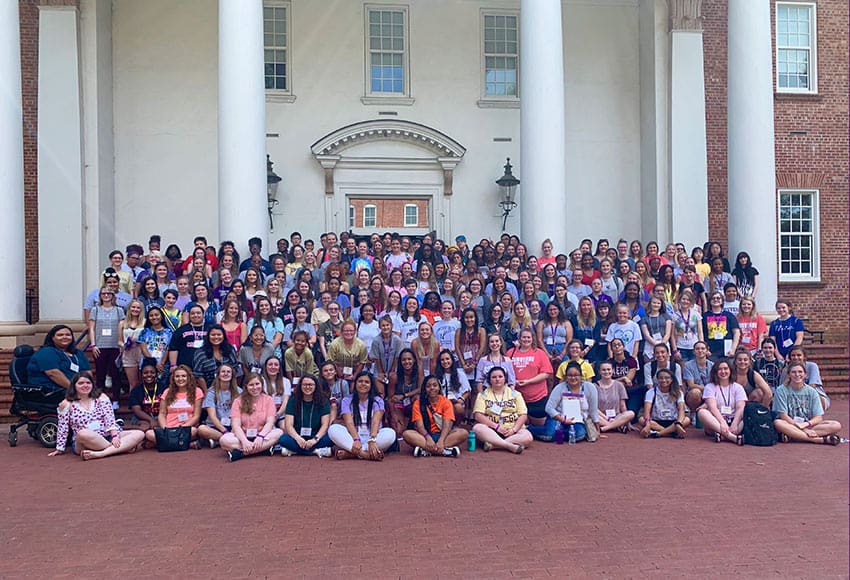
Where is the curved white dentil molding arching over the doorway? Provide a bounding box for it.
[310,119,466,157]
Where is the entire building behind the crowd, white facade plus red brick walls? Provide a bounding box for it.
[0,0,850,342]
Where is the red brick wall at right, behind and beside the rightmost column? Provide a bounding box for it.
[702,0,850,343]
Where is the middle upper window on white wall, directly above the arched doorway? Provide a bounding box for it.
[366,5,410,97]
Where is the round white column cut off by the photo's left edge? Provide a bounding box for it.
[0,0,26,324]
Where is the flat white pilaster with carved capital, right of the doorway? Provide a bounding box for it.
[667,0,710,248]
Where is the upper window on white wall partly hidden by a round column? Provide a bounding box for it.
[263,0,292,100]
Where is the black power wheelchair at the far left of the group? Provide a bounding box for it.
[9,344,65,447]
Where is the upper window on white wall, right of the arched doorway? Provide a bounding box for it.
[483,13,519,99]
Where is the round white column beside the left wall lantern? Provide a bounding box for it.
[218,0,269,255]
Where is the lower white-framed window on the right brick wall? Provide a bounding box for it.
[778,189,820,281]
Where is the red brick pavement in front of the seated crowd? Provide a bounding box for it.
[0,401,850,578]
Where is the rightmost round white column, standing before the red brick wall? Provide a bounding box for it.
[727,0,777,311]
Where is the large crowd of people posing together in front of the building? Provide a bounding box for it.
[29,232,841,461]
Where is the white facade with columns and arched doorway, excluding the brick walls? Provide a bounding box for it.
[0,0,777,323]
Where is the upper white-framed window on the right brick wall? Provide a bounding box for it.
[776,2,817,93]
